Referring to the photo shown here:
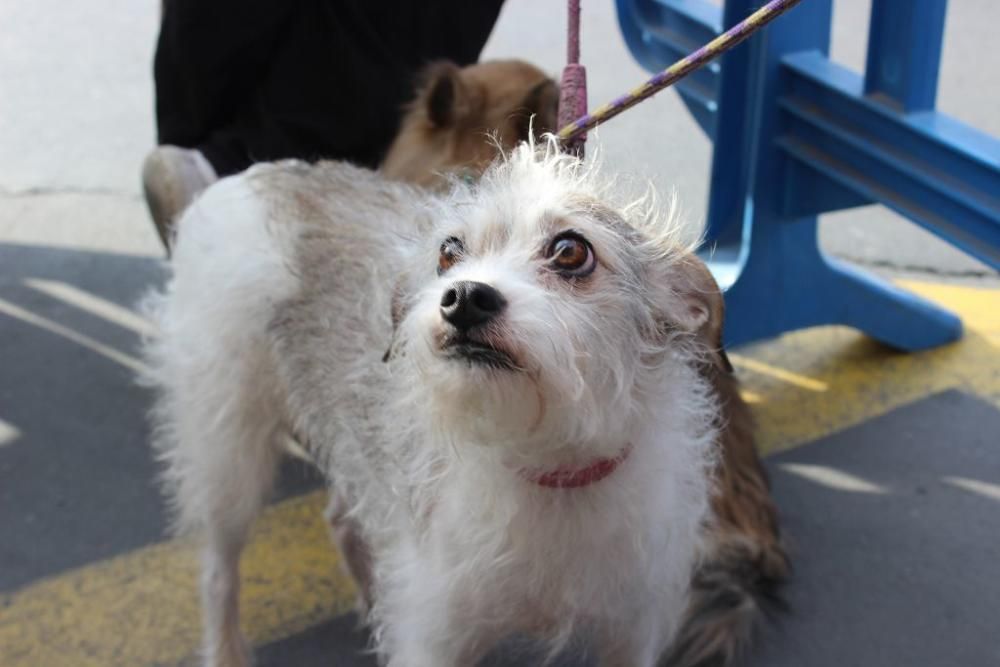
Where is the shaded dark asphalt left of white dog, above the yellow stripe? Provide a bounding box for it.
[0,244,315,591]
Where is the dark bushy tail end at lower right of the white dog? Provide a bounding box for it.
[660,537,789,667]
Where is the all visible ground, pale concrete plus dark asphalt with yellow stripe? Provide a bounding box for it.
[0,0,1000,667]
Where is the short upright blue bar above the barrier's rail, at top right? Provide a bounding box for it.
[865,0,948,111]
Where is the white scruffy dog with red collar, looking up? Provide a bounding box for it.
[148,144,719,667]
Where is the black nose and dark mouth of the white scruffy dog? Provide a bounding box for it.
[441,281,518,370]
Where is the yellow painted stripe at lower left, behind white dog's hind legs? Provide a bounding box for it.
[0,492,353,667]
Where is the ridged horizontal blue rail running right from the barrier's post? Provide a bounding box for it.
[777,53,1000,268]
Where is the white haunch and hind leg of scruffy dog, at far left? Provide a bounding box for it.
[146,177,295,667]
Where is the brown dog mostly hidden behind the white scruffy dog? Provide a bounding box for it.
[390,61,789,666]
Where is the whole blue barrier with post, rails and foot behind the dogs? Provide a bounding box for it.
[617,0,1000,350]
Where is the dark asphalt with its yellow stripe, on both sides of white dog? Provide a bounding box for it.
[0,244,1000,667]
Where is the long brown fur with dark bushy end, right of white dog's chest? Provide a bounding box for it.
[661,255,789,667]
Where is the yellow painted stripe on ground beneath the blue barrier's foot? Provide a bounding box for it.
[737,281,1000,453]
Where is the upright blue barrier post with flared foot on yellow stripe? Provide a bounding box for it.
[711,0,961,350]
